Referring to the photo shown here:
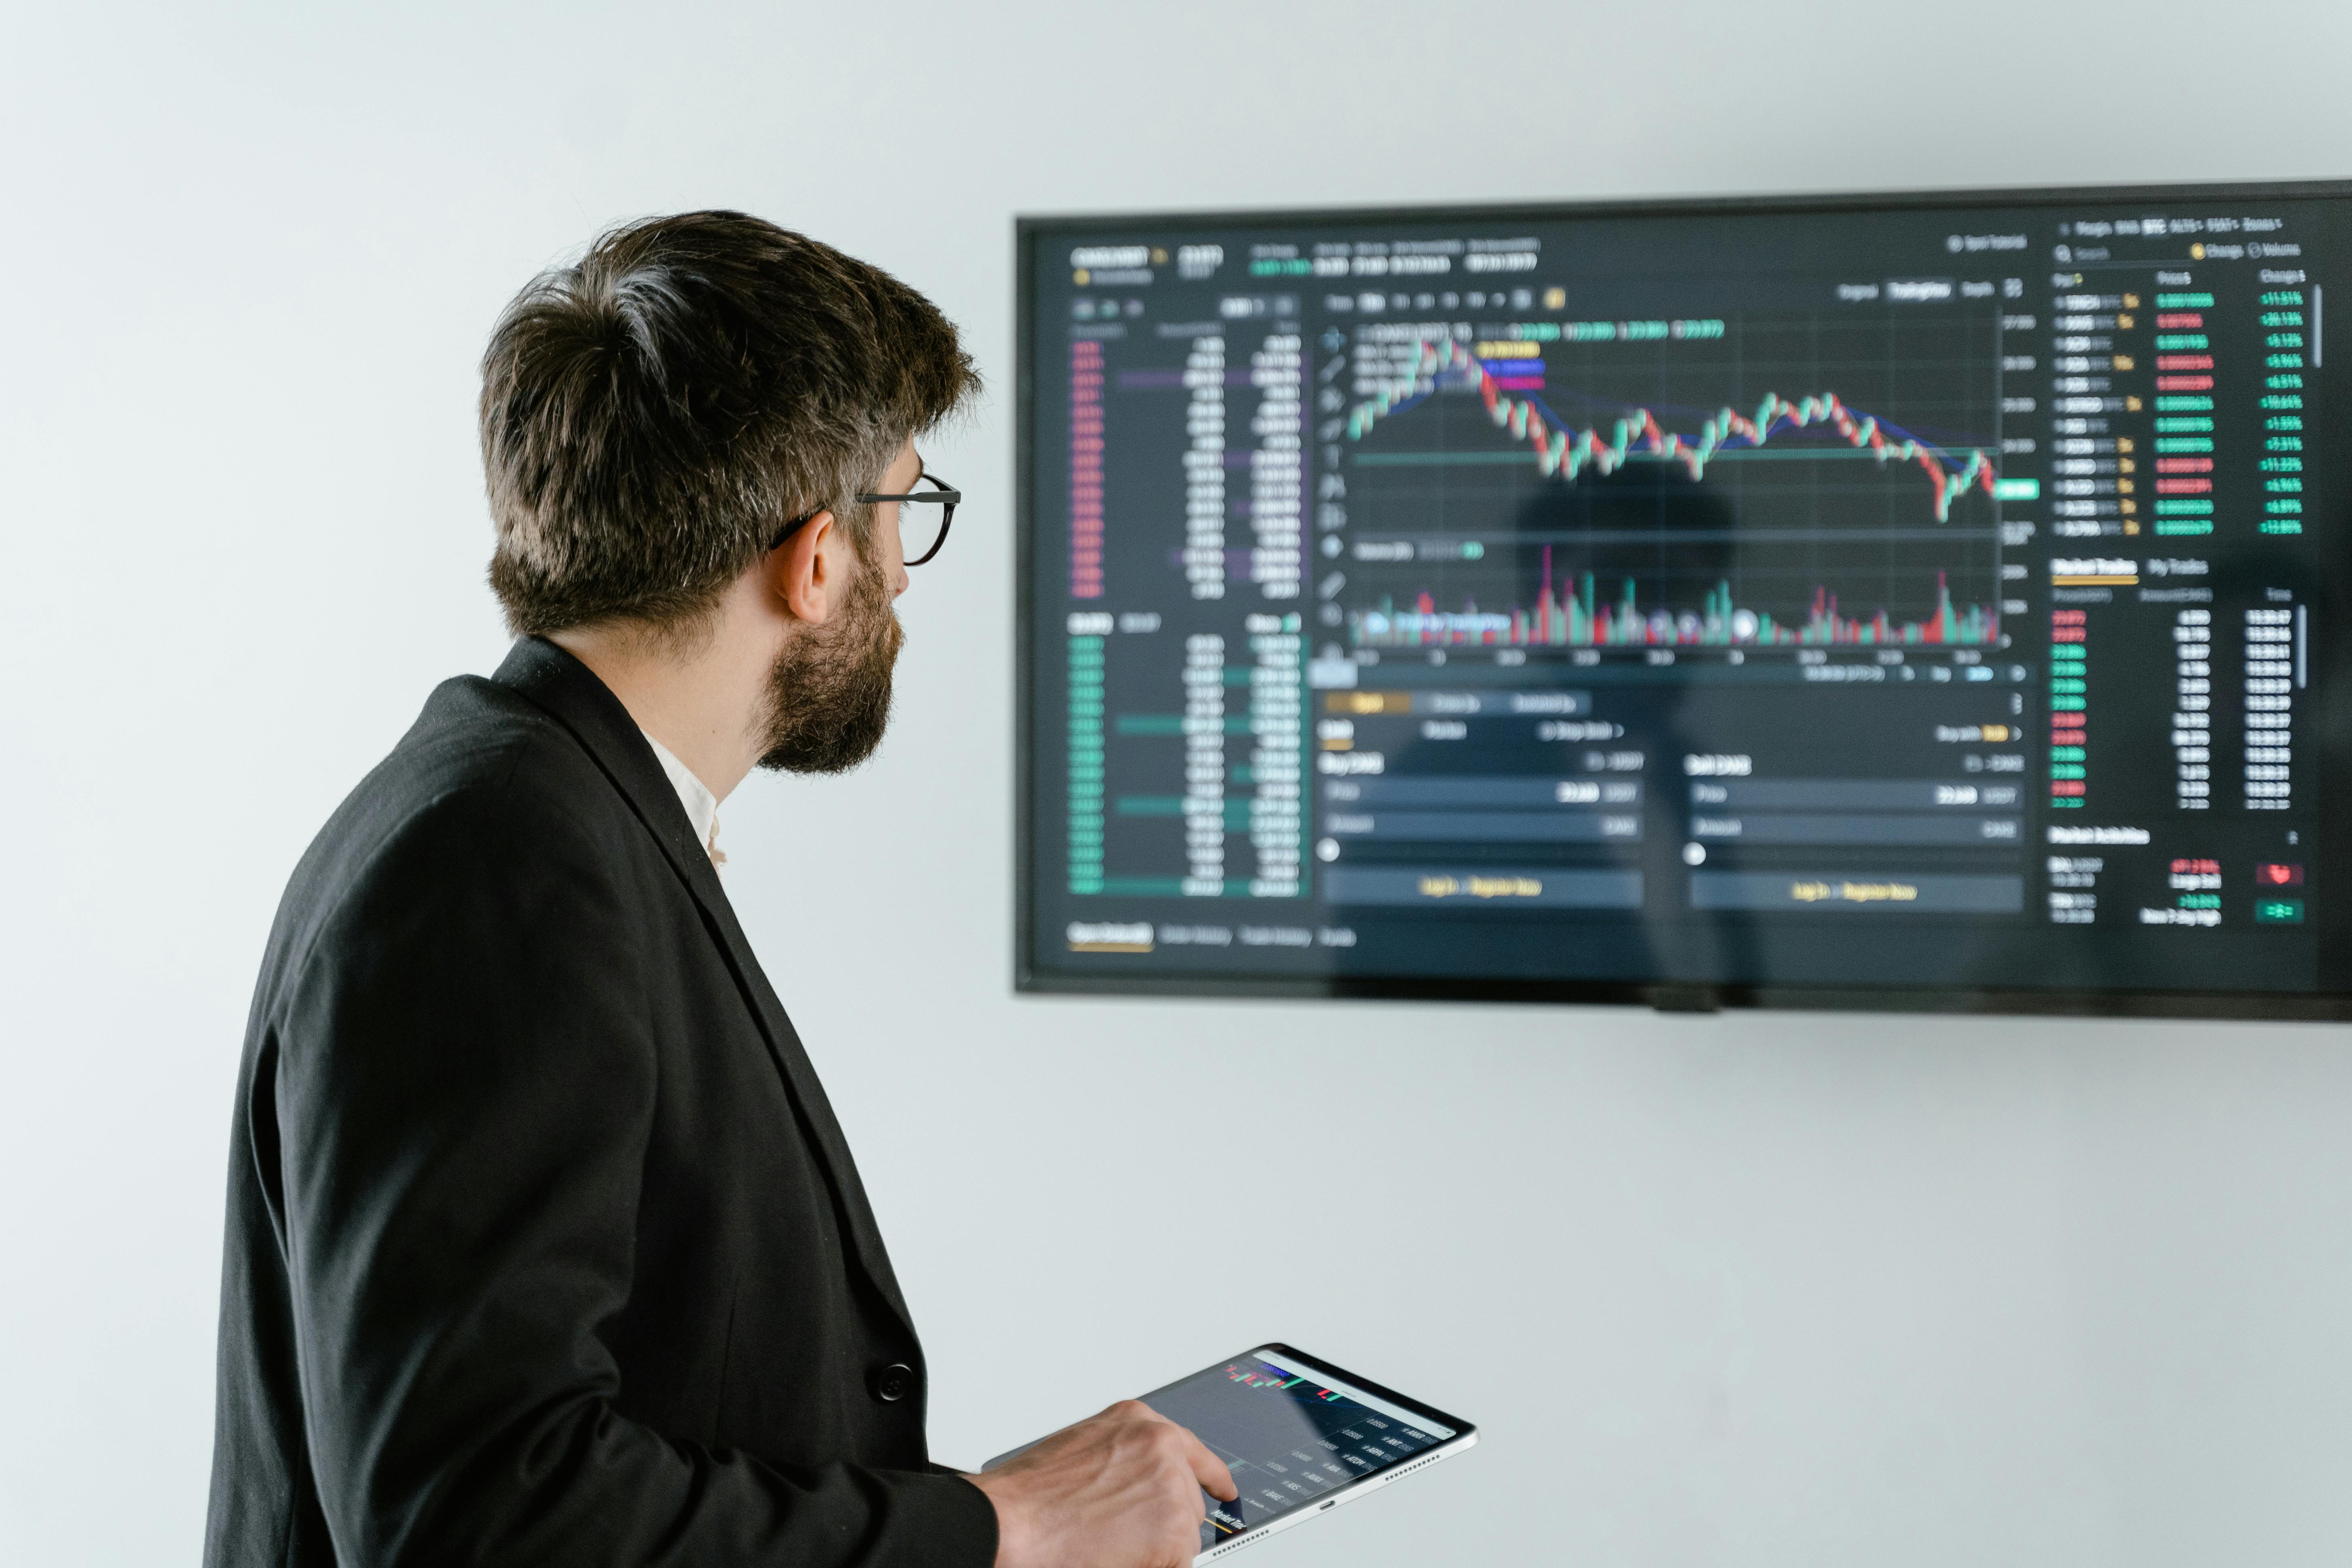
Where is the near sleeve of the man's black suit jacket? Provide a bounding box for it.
[273,790,997,1568]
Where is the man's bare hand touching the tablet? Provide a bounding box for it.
[971,1399,1235,1568]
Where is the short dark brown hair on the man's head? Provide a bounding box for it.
[482,212,981,635]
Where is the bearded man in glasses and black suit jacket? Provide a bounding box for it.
[205,212,1233,1568]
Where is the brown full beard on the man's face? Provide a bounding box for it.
[760,559,905,773]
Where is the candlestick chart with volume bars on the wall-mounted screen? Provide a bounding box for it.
[1324,317,2001,646]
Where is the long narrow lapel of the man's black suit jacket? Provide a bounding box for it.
[492,637,915,1335]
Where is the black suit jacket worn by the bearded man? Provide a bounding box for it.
[205,639,997,1568]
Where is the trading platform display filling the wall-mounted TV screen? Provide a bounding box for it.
[1023,193,2352,1011]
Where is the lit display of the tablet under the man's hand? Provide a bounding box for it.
[1143,1354,1456,1551]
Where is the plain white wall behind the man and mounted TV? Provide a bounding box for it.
[0,0,2352,1568]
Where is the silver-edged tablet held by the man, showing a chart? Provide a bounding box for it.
[986,1345,1477,1568]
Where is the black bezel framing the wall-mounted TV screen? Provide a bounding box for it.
[1014,179,2352,1022]
